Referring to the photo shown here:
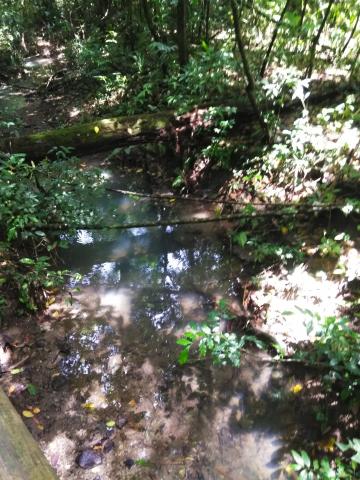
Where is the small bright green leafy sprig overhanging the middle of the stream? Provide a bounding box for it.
[177,301,264,367]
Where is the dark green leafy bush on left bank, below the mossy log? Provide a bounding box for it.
[0,148,102,311]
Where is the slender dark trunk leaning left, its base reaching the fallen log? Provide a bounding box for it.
[230,0,270,142]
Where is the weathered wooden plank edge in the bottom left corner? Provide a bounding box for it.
[0,388,57,480]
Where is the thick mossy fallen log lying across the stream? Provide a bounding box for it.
[0,82,358,160]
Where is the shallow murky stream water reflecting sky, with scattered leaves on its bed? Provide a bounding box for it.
[32,162,310,480]
